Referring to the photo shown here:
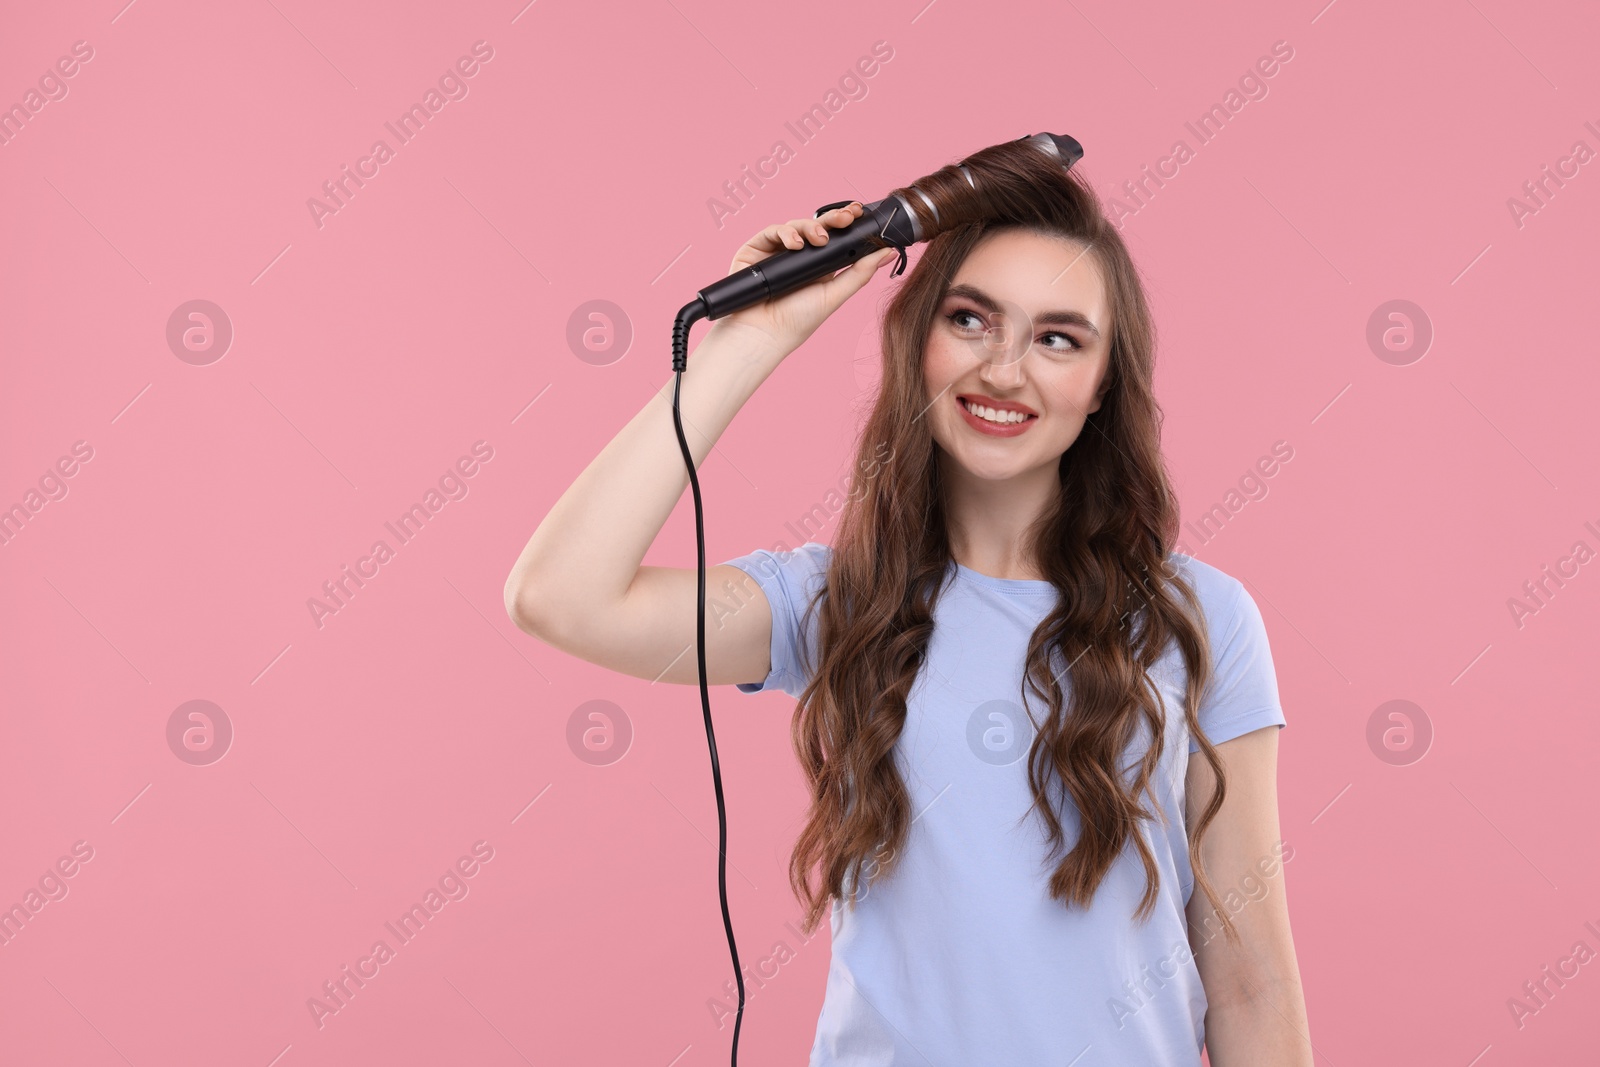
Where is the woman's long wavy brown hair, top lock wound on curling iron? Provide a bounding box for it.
[789,133,1237,937]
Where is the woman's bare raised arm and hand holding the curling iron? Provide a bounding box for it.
[506,205,894,685]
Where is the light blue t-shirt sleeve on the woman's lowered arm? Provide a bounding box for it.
[1189,581,1286,753]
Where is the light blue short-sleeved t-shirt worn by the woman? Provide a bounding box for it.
[728,542,1285,1067]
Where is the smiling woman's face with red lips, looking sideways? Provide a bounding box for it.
[923,229,1110,480]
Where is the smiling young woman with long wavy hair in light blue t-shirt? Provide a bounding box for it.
[506,142,1312,1067]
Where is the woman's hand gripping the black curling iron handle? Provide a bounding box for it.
[706,200,896,360]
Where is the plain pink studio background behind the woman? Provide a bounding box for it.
[0,0,1600,1067]
